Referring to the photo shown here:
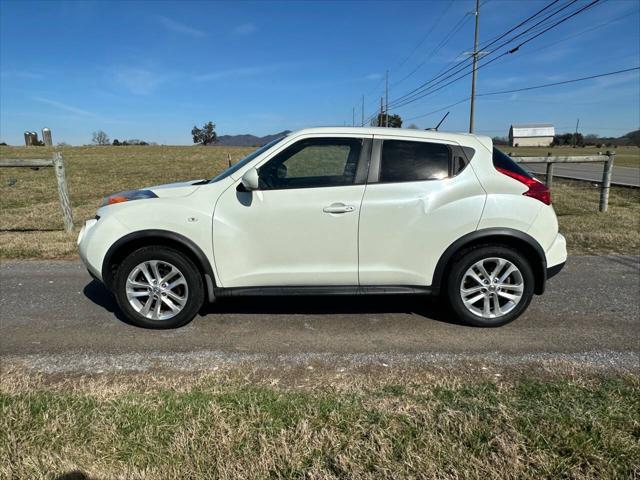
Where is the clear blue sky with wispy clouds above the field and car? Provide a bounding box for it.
[0,0,640,144]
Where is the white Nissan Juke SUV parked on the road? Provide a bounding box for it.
[78,127,567,328]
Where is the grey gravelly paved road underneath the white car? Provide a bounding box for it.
[0,256,640,369]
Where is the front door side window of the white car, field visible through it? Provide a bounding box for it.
[258,138,362,190]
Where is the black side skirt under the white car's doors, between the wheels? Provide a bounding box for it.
[213,285,432,297]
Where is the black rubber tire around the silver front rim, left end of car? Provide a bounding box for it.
[113,246,204,329]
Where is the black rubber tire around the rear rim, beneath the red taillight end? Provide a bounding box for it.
[445,245,535,327]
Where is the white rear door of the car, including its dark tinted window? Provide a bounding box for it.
[359,136,486,286]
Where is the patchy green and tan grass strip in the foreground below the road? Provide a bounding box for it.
[0,365,640,479]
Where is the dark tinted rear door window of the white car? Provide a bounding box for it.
[379,140,451,183]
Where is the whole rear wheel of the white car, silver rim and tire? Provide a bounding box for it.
[446,246,534,327]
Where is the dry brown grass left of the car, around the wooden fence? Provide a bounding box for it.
[0,146,252,259]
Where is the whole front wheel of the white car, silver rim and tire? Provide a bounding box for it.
[114,246,204,328]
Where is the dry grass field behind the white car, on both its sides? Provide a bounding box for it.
[0,146,640,258]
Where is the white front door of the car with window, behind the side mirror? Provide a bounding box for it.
[213,135,372,287]
